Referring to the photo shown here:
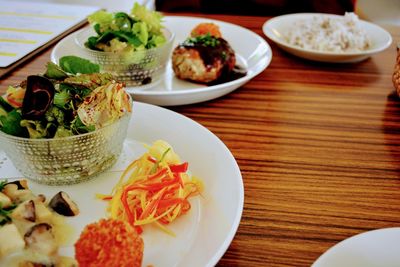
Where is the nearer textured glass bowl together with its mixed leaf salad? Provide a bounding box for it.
[0,56,132,185]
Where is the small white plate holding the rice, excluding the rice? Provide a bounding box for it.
[263,13,392,63]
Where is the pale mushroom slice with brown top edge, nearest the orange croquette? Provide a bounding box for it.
[24,223,58,256]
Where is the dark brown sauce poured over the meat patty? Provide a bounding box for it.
[180,38,247,86]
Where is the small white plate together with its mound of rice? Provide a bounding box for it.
[263,13,392,63]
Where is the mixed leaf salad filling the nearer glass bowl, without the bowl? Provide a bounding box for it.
[0,56,131,138]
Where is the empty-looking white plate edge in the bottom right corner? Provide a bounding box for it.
[312,228,400,267]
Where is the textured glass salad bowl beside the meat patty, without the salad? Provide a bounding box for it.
[75,28,174,86]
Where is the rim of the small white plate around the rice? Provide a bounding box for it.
[262,13,393,58]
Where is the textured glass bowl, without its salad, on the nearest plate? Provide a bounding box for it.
[0,113,131,185]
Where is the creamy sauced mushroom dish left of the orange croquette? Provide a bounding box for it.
[0,180,79,266]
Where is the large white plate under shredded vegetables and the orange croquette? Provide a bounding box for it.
[0,102,244,267]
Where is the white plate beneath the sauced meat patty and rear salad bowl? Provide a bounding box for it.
[51,16,272,106]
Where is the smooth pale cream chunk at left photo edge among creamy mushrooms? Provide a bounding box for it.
[0,224,25,259]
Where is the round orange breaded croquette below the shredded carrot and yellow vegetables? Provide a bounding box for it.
[75,219,144,267]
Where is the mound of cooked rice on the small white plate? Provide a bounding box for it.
[284,12,372,53]
